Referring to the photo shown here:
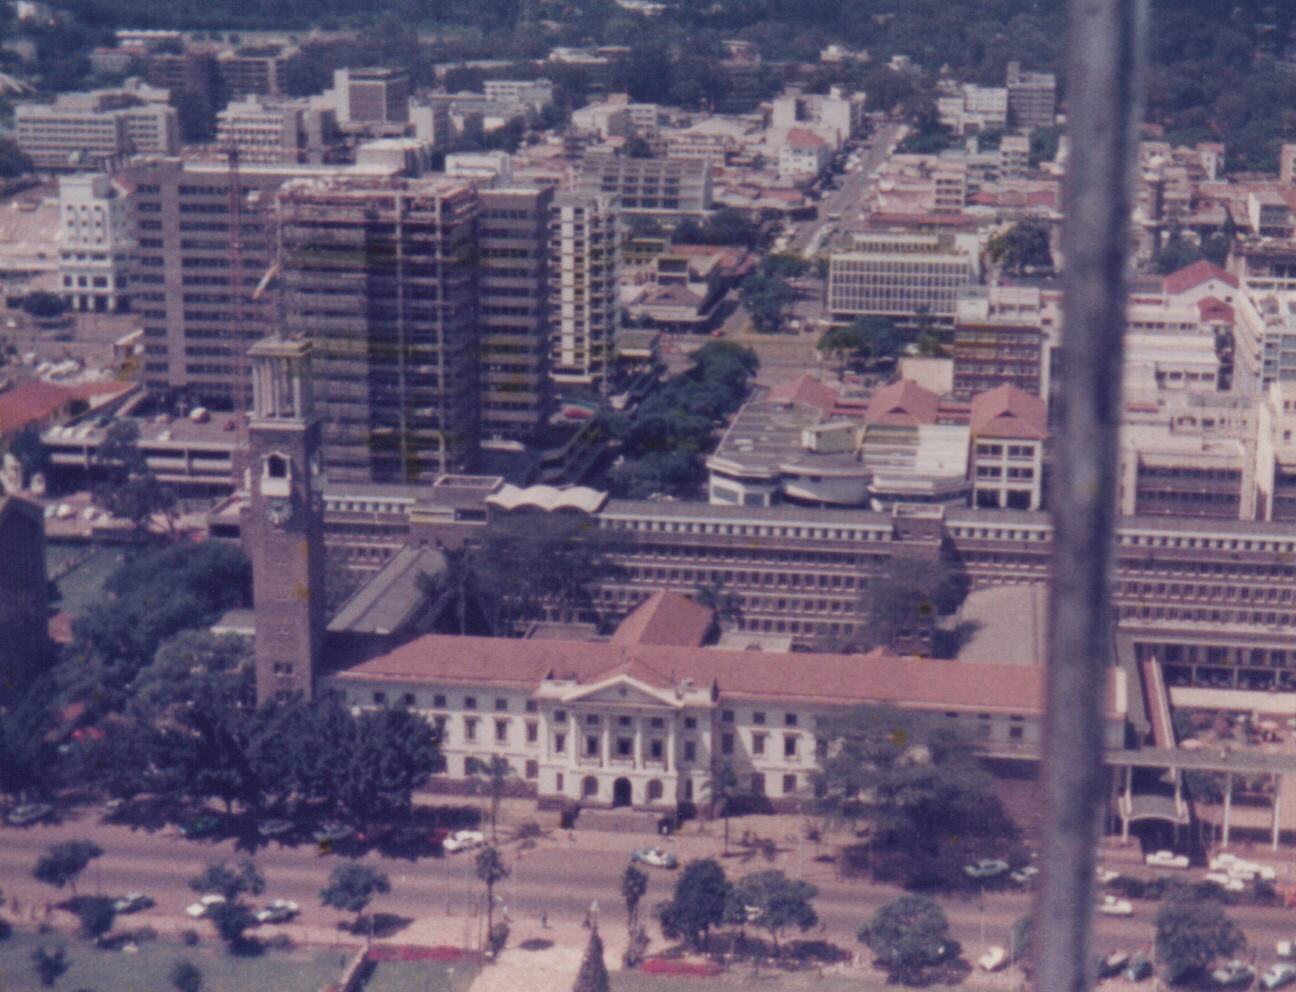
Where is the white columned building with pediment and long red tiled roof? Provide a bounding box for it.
[320,591,1126,812]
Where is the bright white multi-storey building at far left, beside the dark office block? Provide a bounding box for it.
[58,172,133,313]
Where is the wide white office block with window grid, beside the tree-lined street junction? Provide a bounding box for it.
[828,231,981,323]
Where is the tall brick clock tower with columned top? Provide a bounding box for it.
[242,337,325,703]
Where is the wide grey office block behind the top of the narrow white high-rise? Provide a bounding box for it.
[575,153,712,220]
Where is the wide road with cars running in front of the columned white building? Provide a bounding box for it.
[0,812,1296,963]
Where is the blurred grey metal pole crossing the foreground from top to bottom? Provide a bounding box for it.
[1036,0,1143,992]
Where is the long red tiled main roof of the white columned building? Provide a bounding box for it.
[334,634,1117,714]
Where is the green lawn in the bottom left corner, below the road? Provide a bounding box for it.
[0,931,352,992]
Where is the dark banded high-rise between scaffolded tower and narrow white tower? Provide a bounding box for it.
[477,188,553,441]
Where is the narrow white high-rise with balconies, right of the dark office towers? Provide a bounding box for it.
[550,193,621,393]
